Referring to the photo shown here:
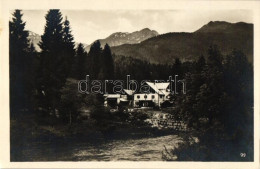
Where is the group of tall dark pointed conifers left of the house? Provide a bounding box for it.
[9,10,114,120]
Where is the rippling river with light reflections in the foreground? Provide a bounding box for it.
[23,135,181,161]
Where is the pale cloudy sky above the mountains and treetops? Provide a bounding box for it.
[10,10,253,44]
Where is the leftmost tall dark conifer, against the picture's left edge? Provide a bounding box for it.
[9,10,32,113]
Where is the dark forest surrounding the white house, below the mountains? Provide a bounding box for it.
[9,10,254,161]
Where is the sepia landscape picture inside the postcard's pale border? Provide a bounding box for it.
[1,1,259,167]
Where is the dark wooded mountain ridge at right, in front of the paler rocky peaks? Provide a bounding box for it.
[111,21,253,64]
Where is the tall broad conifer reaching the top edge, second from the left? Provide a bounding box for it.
[38,10,68,111]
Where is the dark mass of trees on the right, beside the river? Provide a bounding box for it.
[168,45,254,161]
